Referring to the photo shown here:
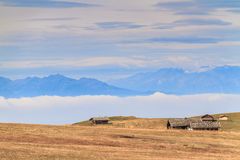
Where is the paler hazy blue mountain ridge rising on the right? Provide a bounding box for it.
[110,66,240,94]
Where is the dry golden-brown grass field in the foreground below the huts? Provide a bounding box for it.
[0,115,240,160]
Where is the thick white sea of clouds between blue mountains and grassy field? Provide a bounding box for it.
[0,93,240,124]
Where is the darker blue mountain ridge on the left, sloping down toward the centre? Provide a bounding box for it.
[0,75,136,98]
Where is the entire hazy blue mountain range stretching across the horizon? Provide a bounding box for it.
[0,66,240,98]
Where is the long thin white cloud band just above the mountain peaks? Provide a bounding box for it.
[0,54,240,71]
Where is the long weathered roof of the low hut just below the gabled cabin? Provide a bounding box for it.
[190,121,221,129]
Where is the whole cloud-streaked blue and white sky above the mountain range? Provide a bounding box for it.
[0,0,240,81]
